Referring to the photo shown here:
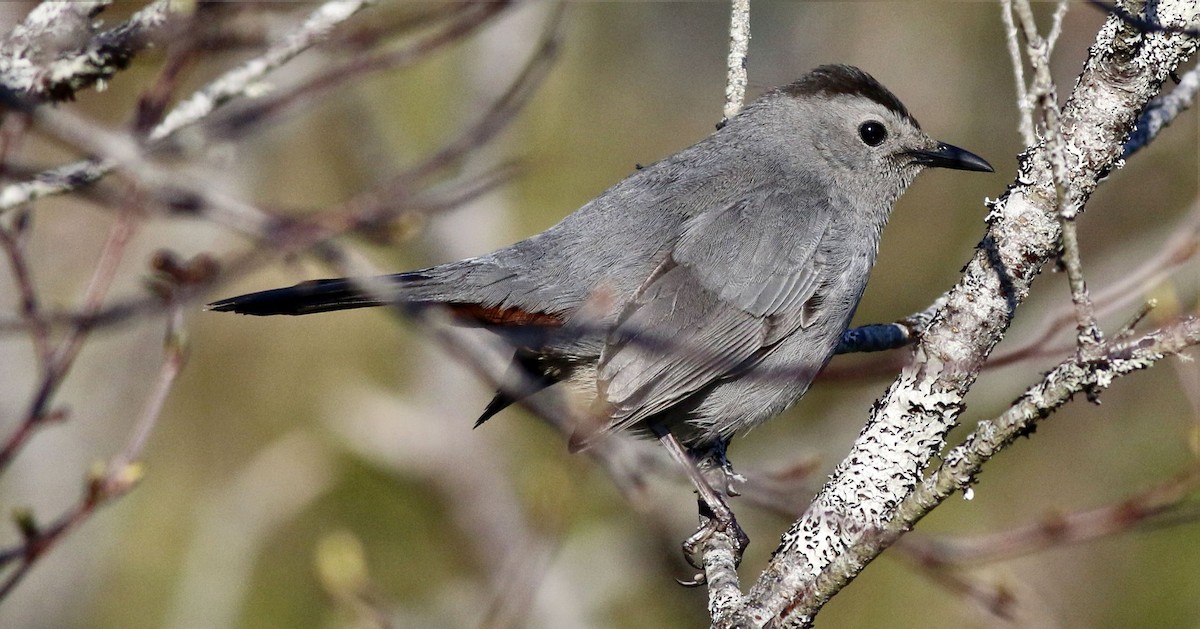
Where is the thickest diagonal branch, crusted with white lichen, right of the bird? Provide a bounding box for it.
[738,1,1195,627]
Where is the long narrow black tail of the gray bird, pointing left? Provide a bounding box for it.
[208,278,392,317]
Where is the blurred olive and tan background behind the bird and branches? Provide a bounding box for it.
[0,0,1200,629]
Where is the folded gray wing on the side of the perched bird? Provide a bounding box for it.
[598,184,830,432]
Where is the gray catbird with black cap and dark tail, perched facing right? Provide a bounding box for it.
[210,65,991,475]
